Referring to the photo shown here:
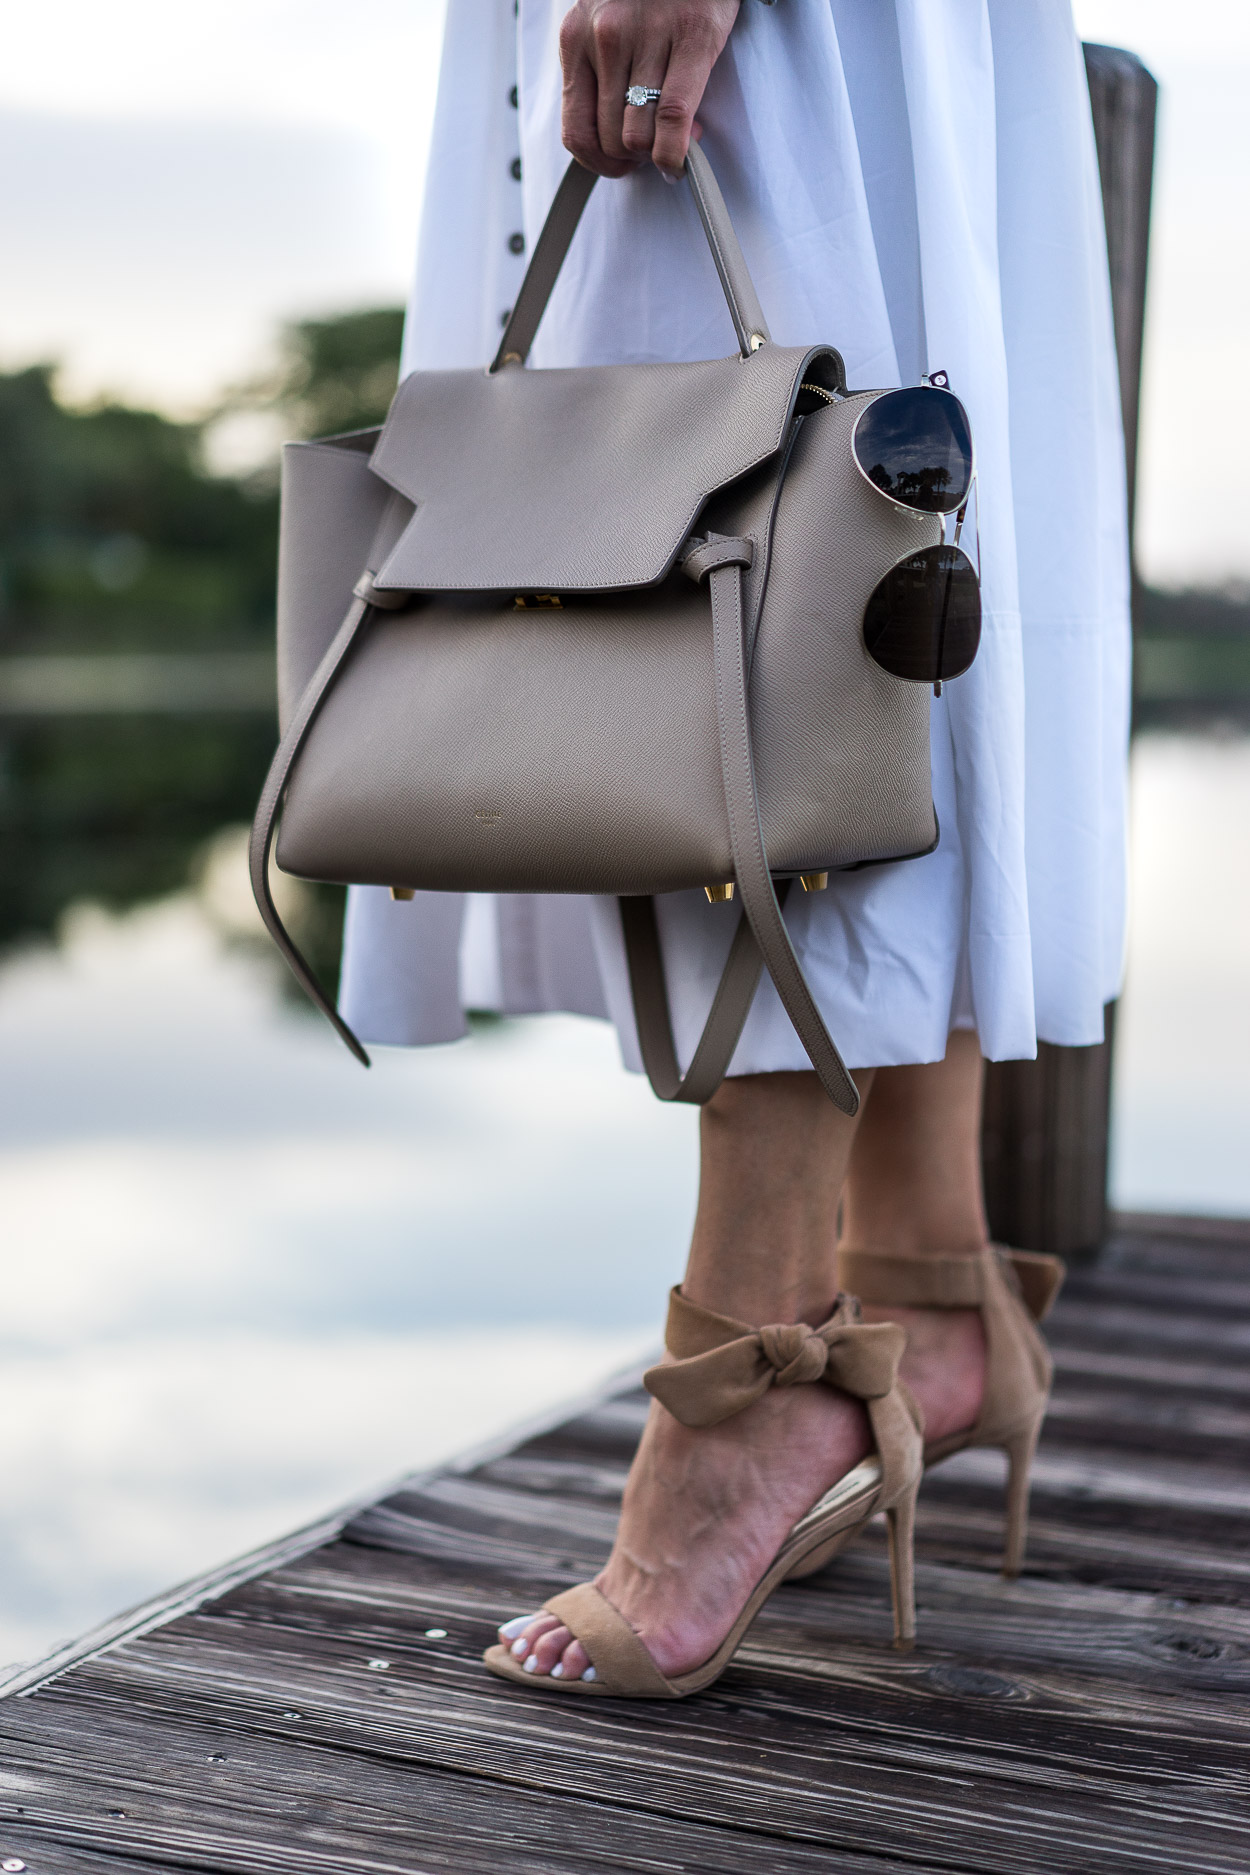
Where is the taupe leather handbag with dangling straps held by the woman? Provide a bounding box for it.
[251,144,941,1112]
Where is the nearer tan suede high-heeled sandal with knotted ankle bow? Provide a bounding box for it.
[485,1288,924,1699]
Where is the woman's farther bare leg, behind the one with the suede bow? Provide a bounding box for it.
[841,1029,988,1438]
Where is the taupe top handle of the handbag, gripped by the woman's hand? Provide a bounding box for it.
[491,141,768,371]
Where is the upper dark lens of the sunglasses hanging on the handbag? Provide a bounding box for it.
[855,384,973,514]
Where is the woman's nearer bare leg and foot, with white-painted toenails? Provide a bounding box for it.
[504,1074,871,1676]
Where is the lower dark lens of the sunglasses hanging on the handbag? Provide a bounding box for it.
[864,548,980,684]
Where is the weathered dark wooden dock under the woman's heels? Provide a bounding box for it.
[0,1219,1250,1875]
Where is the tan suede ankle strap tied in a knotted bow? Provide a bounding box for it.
[643,1288,905,1425]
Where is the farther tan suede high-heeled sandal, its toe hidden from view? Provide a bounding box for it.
[832,1245,1066,1575]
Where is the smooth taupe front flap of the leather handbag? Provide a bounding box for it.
[371,345,838,593]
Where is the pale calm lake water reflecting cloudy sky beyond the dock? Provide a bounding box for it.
[0,737,1250,1661]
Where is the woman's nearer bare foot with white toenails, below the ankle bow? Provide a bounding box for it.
[499,1387,869,1680]
